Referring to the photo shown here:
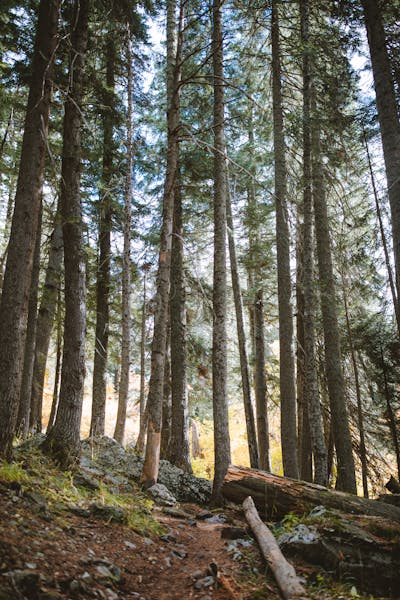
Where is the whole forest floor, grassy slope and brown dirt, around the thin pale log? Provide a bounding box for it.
[0,438,390,600]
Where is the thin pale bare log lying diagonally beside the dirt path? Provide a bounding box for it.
[243,496,307,600]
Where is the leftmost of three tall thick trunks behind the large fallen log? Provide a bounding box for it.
[271,0,299,479]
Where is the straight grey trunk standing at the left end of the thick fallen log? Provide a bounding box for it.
[211,0,231,505]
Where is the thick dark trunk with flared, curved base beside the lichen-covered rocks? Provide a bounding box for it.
[43,0,89,468]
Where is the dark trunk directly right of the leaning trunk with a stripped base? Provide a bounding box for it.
[168,169,192,473]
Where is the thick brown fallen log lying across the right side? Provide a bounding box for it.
[222,465,400,522]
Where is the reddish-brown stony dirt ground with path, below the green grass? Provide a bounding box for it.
[0,484,278,600]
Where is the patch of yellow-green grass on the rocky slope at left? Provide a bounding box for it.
[0,449,164,536]
